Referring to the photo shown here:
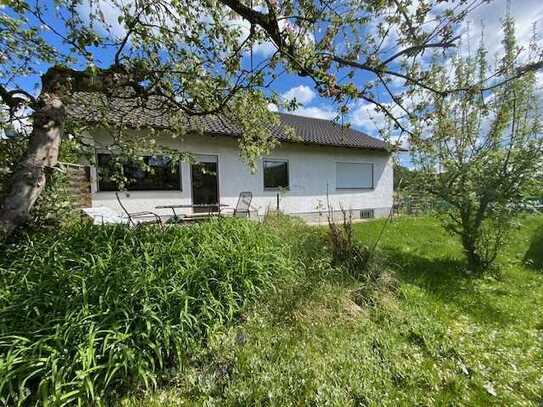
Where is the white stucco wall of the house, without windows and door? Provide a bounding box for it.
[90,130,393,220]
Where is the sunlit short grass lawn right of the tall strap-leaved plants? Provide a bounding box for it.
[129,217,543,406]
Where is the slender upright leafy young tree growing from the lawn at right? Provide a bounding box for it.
[412,18,543,271]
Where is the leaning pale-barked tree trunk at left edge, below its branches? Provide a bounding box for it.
[0,93,66,241]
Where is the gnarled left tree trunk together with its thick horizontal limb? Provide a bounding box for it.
[0,65,140,241]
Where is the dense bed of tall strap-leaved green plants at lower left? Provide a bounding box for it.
[0,219,296,405]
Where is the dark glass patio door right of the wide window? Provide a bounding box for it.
[191,155,219,212]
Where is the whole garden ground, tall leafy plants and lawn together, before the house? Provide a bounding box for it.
[0,215,543,406]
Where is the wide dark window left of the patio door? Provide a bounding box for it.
[97,154,181,191]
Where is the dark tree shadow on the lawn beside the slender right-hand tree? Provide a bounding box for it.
[384,248,514,325]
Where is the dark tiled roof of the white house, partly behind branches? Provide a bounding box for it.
[67,93,392,150]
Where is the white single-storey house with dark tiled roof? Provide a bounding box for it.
[68,95,393,222]
